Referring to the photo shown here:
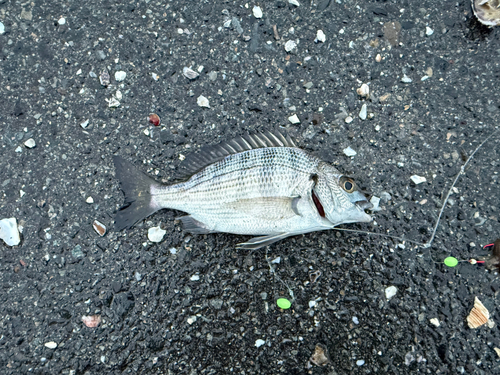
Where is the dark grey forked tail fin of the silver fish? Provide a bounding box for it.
[113,156,161,231]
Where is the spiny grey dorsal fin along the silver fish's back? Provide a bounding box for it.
[177,131,297,179]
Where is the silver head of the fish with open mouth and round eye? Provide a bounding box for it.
[311,163,373,226]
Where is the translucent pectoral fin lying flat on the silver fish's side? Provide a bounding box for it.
[225,197,300,221]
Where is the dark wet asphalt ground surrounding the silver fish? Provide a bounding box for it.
[0,0,500,375]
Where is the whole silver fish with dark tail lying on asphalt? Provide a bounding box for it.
[113,131,372,250]
